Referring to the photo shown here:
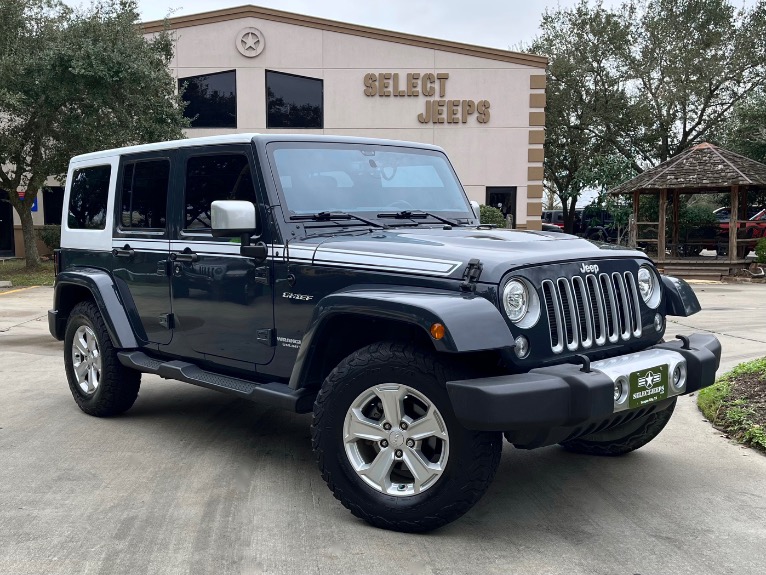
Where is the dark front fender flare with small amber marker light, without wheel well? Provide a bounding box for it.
[290,286,513,388]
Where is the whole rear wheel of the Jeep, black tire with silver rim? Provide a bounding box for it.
[64,302,141,417]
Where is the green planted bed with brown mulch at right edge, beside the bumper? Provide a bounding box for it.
[697,358,766,452]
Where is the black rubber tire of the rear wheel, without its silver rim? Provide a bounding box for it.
[64,301,141,417]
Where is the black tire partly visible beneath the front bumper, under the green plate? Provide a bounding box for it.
[561,399,676,456]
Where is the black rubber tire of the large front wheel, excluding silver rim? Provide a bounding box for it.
[311,342,502,532]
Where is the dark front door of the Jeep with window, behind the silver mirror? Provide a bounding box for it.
[167,145,274,369]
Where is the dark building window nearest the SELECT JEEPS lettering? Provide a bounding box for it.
[266,70,324,128]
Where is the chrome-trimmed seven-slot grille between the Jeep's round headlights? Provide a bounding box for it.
[542,272,641,353]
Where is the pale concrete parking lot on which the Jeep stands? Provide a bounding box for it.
[0,284,766,575]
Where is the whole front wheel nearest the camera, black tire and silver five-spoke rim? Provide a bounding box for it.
[311,343,502,532]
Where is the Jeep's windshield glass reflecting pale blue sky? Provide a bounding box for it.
[268,142,473,218]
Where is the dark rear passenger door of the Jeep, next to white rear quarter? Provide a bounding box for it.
[111,151,173,344]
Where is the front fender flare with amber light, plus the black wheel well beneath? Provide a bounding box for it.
[290,287,513,389]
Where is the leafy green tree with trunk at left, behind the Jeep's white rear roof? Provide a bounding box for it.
[0,0,188,267]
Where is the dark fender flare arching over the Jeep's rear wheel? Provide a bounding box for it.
[48,268,140,349]
